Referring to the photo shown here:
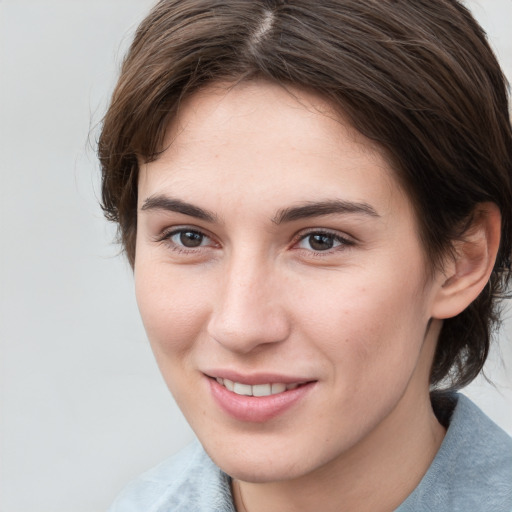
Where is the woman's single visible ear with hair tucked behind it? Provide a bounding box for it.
[432,203,501,319]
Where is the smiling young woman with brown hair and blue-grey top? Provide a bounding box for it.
[99,0,512,512]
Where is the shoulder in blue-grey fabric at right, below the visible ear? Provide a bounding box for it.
[398,394,512,512]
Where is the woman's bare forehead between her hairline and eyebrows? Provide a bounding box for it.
[139,81,407,222]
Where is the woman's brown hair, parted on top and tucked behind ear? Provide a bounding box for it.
[99,0,512,387]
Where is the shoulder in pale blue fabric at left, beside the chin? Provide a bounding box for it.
[108,441,234,512]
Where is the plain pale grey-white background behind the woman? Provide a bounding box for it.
[0,0,512,512]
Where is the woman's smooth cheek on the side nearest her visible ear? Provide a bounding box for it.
[294,269,428,385]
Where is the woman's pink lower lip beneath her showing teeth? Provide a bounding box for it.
[208,377,315,423]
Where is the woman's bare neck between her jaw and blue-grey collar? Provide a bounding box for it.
[233,324,445,512]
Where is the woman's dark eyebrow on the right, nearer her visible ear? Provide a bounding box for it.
[272,199,380,224]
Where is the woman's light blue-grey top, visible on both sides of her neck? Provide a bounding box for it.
[108,394,512,512]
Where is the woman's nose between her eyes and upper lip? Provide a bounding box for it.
[208,255,290,354]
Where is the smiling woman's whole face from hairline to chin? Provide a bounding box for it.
[135,82,444,482]
